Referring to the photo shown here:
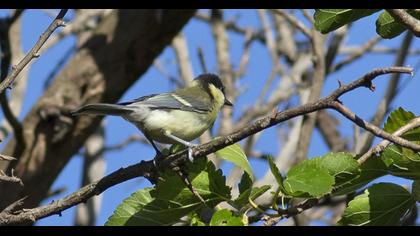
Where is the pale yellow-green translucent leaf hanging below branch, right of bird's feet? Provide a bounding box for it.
[216,143,253,176]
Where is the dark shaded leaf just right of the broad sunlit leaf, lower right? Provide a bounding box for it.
[333,156,388,195]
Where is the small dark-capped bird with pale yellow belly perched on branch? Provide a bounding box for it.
[72,74,232,160]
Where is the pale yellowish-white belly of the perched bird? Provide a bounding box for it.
[133,110,214,144]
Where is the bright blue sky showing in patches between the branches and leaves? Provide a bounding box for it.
[0,10,420,225]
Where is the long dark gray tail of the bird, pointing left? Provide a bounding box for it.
[71,103,131,116]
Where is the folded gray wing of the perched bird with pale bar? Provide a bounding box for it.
[118,93,211,113]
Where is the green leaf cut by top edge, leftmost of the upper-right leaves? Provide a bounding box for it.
[314,9,379,34]
